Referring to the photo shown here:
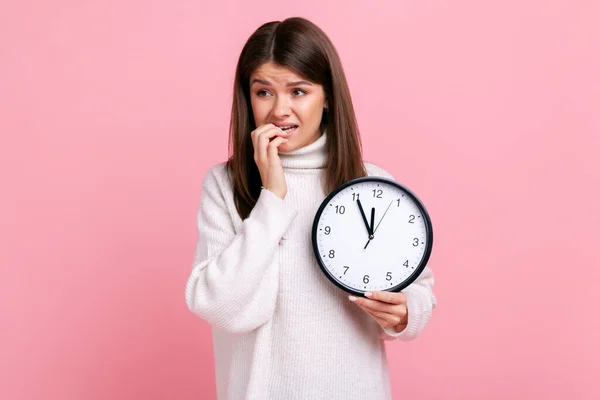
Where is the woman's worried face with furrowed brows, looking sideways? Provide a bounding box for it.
[250,62,327,152]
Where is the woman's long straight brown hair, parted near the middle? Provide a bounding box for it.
[227,17,367,220]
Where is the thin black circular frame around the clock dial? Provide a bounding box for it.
[312,176,433,296]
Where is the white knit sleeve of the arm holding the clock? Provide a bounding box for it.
[365,163,437,341]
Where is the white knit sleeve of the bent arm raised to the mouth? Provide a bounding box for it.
[185,164,297,333]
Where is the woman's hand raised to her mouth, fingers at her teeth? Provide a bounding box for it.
[251,124,288,199]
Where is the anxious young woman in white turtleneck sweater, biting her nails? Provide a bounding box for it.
[186,18,436,400]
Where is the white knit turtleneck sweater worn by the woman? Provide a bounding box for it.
[185,134,436,400]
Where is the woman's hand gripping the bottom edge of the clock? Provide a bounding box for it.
[349,290,408,332]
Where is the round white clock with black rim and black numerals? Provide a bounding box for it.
[312,177,433,295]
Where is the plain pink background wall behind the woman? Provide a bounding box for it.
[0,0,600,400]
